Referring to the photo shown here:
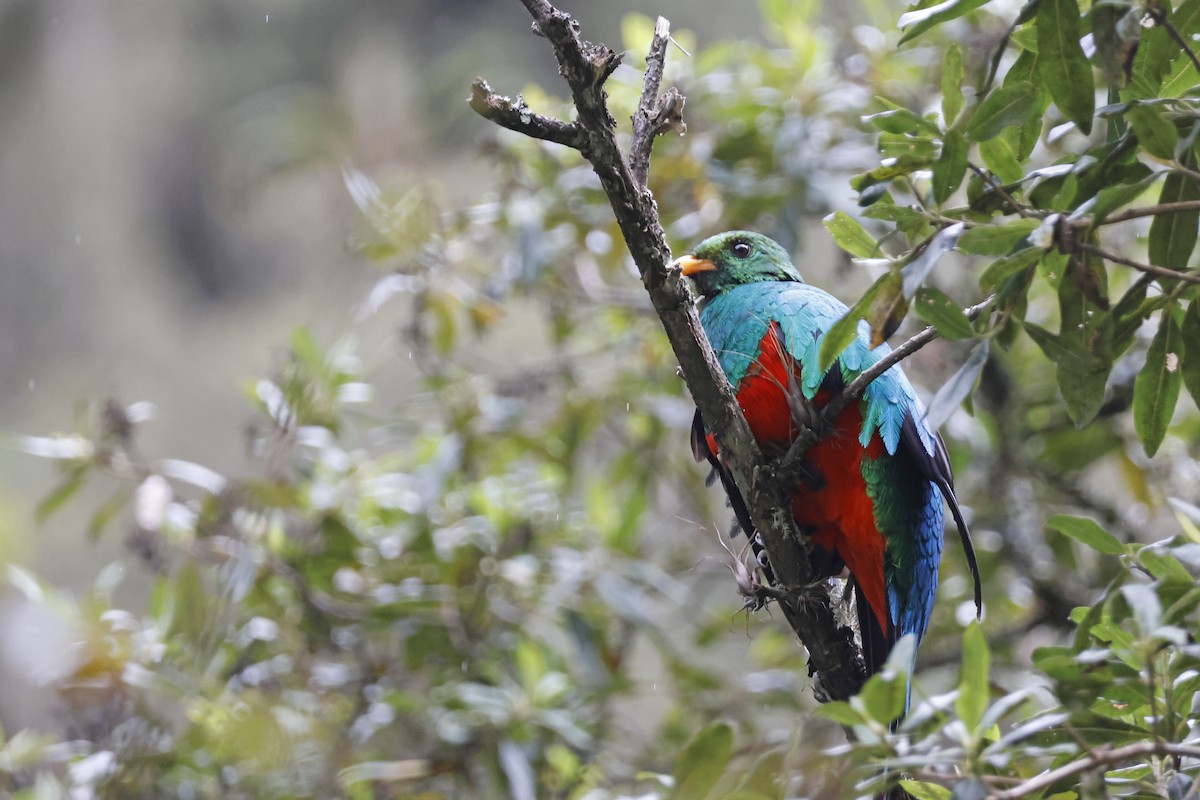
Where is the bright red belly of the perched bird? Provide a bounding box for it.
[708,325,892,632]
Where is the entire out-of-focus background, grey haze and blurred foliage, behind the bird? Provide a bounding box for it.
[0,0,1200,798]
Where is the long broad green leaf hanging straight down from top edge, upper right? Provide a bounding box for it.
[1037,0,1096,134]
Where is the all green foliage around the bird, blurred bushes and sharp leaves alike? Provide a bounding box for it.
[7,0,1200,800]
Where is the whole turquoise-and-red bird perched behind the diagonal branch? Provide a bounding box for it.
[676,230,980,673]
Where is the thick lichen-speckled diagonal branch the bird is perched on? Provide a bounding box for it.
[476,0,866,699]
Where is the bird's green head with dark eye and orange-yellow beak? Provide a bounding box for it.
[674,230,804,300]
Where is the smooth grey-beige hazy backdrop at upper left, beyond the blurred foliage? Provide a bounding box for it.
[0,0,761,584]
